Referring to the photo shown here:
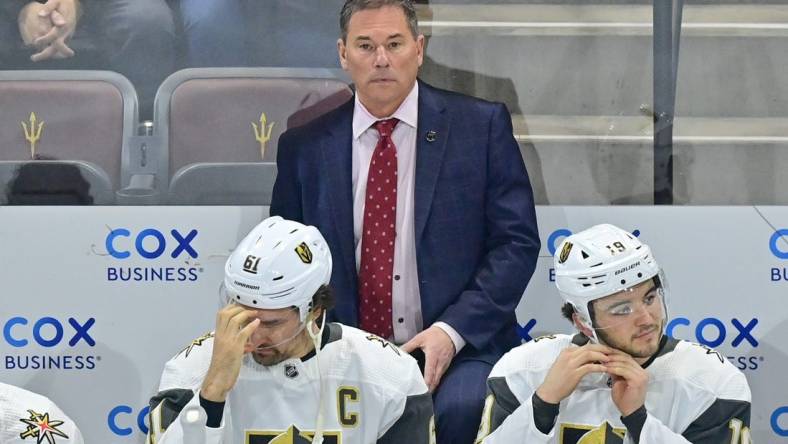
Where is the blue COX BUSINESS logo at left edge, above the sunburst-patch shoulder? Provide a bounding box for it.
[3,316,101,370]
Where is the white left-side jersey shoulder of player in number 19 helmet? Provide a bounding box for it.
[490,334,573,378]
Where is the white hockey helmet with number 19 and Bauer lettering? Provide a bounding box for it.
[553,224,664,332]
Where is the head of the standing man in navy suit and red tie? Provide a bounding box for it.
[337,6,424,117]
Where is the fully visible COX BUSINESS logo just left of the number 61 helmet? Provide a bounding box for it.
[104,228,203,282]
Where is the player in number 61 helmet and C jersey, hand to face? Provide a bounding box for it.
[149,217,433,444]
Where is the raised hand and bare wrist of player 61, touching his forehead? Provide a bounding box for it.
[200,304,260,402]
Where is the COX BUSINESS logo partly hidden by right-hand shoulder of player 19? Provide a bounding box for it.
[665,317,764,370]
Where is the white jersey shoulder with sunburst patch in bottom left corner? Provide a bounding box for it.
[0,383,84,444]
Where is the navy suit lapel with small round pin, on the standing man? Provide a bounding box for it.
[414,82,449,245]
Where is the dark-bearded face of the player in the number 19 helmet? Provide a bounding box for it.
[593,280,665,359]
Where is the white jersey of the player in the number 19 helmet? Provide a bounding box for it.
[477,335,751,444]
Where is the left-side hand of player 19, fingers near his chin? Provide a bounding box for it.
[536,343,613,404]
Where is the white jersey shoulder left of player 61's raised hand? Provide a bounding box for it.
[159,332,214,390]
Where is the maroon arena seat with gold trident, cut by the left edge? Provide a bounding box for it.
[0,70,137,203]
